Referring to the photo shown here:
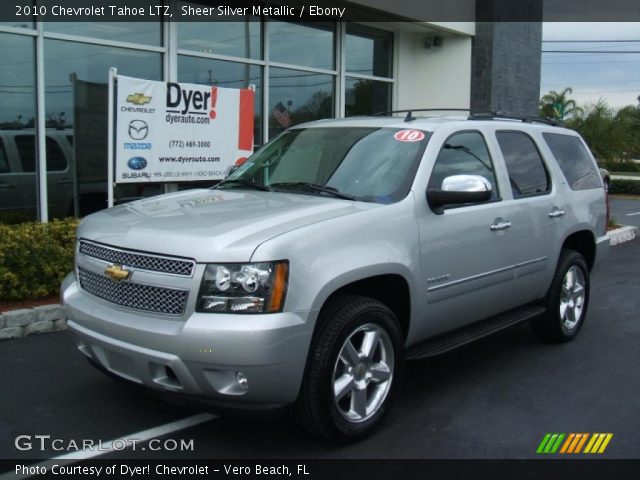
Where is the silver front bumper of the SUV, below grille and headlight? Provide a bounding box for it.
[61,274,313,408]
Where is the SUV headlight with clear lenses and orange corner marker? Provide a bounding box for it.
[196,261,289,313]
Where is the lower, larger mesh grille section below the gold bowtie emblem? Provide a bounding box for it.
[78,267,189,315]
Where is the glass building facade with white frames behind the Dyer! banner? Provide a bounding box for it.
[0,8,395,223]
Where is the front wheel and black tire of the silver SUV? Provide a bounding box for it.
[296,295,404,443]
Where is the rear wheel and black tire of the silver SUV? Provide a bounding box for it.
[531,250,590,343]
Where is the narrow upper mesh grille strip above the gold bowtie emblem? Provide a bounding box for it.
[79,240,195,277]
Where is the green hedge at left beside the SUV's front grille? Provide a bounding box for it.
[0,218,78,300]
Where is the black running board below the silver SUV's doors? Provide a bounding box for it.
[406,304,546,360]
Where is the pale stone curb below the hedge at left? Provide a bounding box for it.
[0,304,67,341]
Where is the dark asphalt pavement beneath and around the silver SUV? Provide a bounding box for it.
[0,237,640,461]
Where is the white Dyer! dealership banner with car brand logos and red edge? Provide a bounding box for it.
[113,75,254,183]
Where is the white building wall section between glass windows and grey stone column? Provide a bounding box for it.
[394,31,472,110]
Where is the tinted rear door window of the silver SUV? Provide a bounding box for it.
[496,132,551,198]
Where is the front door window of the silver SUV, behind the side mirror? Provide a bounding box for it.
[427,132,498,200]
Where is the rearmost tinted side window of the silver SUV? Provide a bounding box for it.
[542,133,602,190]
